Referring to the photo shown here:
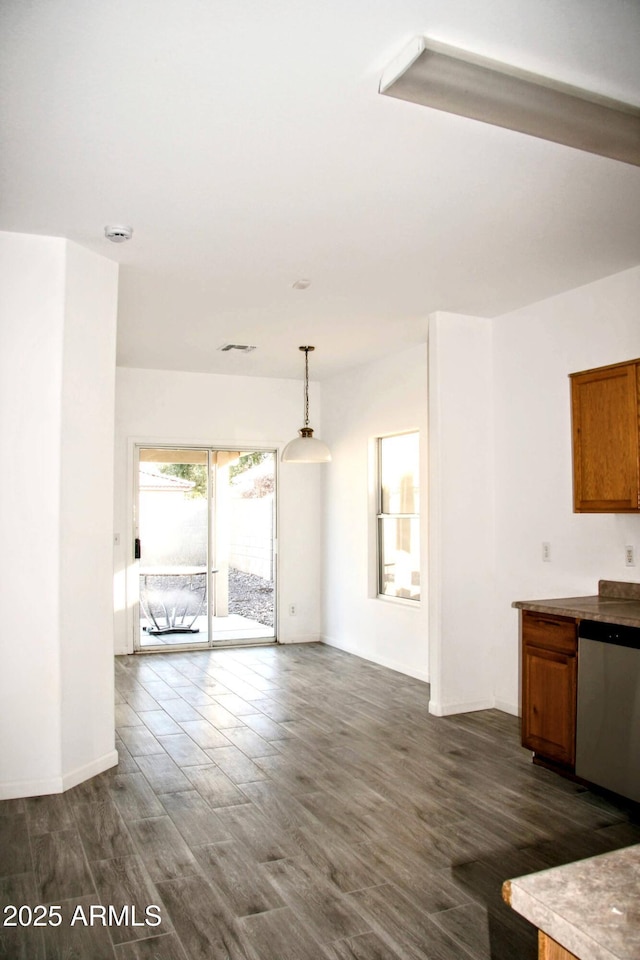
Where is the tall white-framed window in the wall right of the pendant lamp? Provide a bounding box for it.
[378,433,420,600]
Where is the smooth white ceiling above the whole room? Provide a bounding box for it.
[0,0,640,379]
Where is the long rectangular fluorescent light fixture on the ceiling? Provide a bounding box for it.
[380,37,640,166]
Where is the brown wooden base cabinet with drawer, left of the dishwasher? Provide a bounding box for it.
[522,610,578,770]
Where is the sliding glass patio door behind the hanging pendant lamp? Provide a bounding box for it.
[134,446,277,651]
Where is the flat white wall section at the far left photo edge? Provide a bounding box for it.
[0,233,65,797]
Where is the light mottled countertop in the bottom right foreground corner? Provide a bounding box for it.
[503,844,640,960]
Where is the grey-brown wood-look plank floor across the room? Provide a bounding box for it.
[0,644,640,960]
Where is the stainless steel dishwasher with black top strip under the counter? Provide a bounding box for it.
[576,620,640,802]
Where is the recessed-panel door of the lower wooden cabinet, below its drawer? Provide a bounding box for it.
[522,642,577,767]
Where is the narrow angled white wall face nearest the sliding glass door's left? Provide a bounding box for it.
[60,243,118,787]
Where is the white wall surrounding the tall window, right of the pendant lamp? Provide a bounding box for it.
[319,344,429,680]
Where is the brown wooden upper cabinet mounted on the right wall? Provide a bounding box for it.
[570,360,640,513]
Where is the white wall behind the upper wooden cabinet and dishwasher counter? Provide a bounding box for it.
[493,267,640,712]
